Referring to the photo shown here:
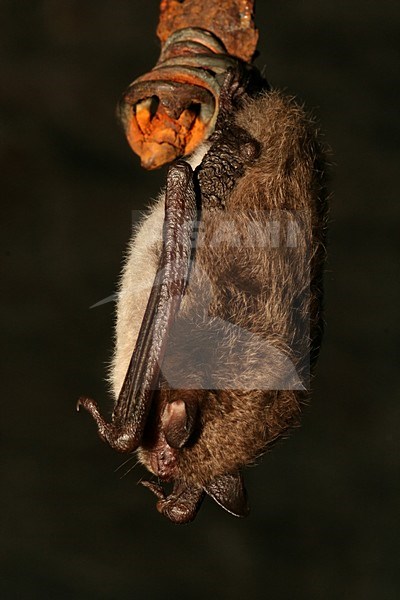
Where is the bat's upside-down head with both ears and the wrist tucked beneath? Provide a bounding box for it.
[139,390,249,524]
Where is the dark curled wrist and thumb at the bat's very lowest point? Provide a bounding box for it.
[142,481,204,525]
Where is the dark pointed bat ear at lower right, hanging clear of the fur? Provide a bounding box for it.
[204,471,249,517]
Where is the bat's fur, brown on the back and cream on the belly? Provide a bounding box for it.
[111,92,326,486]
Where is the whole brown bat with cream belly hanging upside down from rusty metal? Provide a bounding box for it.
[78,69,326,523]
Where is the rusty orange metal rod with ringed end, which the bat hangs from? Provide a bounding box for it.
[119,0,258,169]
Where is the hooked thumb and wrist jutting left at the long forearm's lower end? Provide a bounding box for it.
[76,398,139,452]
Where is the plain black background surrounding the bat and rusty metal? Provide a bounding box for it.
[0,0,400,600]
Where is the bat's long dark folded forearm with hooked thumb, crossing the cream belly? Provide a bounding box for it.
[77,161,197,452]
